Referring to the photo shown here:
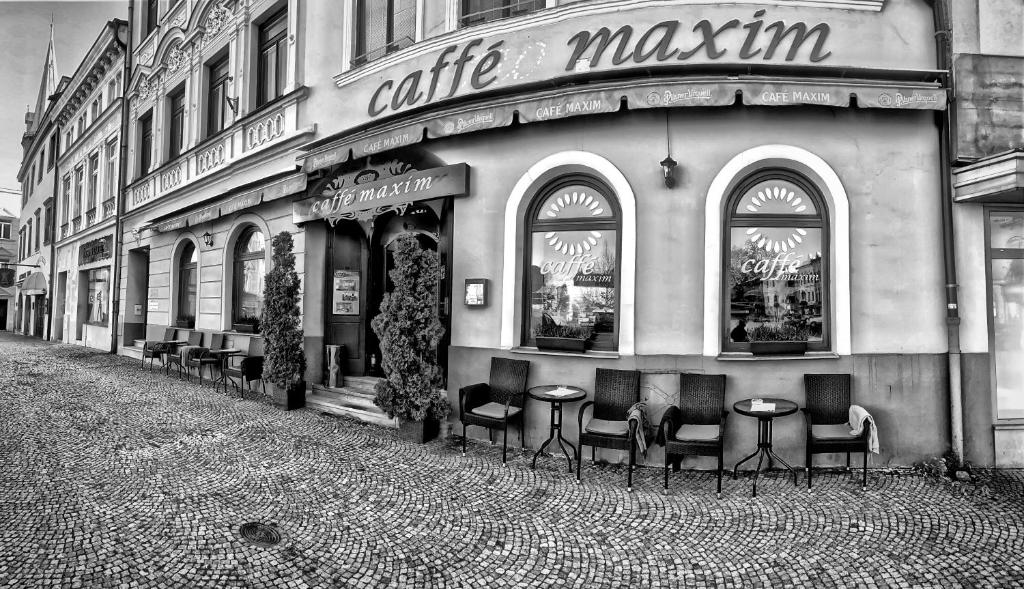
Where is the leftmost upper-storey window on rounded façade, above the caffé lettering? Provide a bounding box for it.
[352,0,416,67]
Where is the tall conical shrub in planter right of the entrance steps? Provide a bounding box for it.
[371,235,452,441]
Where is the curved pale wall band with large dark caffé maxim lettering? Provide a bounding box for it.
[333,0,936,128]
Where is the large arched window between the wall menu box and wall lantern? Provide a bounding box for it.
[521,176,622,350]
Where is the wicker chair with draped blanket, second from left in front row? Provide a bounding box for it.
[575,368,640,491]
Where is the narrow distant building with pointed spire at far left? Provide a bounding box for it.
[14,27,63,338]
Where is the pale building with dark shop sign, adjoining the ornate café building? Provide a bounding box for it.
[52,19,128,350]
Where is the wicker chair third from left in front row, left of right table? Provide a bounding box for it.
[658,374,729,499]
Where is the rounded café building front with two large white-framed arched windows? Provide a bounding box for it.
[293,0,949,465]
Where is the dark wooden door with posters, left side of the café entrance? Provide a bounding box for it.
[324,221,369,376]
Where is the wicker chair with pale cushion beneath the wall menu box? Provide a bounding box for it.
[459,357,529,464]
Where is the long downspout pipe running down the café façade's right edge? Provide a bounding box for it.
[930,0,964,467]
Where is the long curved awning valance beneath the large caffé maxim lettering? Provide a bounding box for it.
[299,76,946,172]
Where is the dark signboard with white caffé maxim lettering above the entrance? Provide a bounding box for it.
[292,164,469,223]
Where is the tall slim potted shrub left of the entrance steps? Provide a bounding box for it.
[260,232,306,411]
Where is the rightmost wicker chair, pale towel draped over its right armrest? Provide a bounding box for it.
[801,374,872,490]
